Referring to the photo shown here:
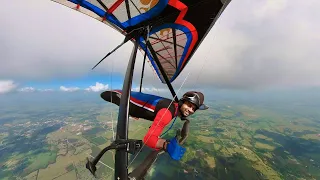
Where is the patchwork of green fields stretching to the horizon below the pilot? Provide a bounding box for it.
[0,93,320,180]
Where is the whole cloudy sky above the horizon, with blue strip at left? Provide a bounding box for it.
[0,0,320,95]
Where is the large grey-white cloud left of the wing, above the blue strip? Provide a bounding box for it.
[0,0,132,80]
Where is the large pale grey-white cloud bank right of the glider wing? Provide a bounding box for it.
[177,0,320,89]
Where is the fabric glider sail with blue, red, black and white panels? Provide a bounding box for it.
[52,0,231,83]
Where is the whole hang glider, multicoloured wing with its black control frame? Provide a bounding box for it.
[51,0,231,179]
